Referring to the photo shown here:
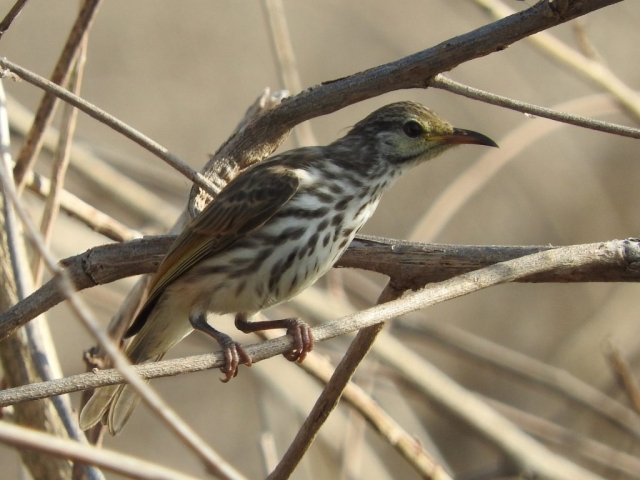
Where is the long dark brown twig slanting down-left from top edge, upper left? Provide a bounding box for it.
[14,0,100,192]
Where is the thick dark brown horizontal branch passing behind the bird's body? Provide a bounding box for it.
[0,235,640,339]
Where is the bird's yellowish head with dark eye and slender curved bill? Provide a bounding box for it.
[345,102,498,165]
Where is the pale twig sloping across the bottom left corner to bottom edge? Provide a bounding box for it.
[0,422,200,480]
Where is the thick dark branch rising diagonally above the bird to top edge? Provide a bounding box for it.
[196,0,621,204]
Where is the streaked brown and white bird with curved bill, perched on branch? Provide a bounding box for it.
[80,101,498,435]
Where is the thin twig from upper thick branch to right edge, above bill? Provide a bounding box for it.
[429,74,640,139]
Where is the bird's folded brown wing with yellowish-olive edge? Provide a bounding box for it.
[125,162,300,338]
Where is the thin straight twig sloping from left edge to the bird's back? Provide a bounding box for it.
[0,58,218,194]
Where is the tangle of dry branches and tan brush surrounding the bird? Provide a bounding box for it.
[0,0,640,480]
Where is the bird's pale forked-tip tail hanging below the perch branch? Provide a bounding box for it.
[80,304,193,435]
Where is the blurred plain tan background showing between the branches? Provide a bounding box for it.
[0,0,640,479]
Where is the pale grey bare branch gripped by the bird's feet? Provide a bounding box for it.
[0,240,637,407]
